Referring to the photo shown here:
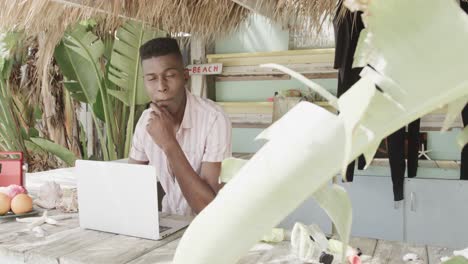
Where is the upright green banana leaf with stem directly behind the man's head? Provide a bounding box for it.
[108,21,167,156]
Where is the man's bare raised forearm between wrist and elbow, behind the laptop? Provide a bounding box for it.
[165,141,216,214]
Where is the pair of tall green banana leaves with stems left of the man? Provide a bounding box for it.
[54,21,165,160]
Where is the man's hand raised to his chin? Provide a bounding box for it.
[146,103,177,151]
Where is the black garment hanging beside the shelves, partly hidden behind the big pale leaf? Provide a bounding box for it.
[333,1,366,181]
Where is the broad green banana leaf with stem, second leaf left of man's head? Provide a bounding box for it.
[55,25,117,160]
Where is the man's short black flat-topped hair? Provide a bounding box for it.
[140,38,182,61]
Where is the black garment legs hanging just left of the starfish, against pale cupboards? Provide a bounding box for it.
[387,119,421,201]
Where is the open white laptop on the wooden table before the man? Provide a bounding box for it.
[75,160,190,240]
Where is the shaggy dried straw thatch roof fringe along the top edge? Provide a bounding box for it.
[0,0,335,39]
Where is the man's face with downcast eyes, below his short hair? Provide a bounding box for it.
[142,54,188,114]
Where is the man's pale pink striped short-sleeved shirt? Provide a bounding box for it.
[129,91,232,215]
